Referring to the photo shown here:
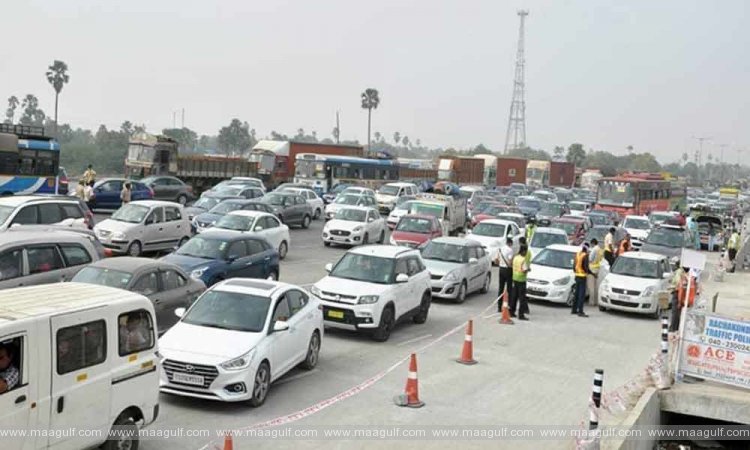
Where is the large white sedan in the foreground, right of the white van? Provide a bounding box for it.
[159,278,324,407]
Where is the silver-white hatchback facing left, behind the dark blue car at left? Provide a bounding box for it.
[94,200,191,256]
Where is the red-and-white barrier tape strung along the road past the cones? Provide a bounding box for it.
[199,297,500,450]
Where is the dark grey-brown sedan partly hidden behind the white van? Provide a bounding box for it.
[71,256,206,334]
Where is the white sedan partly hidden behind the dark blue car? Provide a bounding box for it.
[209,210,291,259]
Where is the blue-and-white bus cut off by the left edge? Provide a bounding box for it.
[0,124,67,195]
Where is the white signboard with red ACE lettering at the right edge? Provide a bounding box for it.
[679,312,750,389]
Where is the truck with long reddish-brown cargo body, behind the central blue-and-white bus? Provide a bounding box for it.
[250,140,364,186]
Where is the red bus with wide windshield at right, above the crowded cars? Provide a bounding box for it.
[595,175,672,217]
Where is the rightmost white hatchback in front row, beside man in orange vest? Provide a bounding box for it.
[599,251,672,319]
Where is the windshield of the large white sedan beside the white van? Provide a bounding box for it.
[182,290,271,333]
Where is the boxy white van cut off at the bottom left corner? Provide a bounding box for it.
[0,283,159,450]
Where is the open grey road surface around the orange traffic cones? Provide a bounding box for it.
[98,215,660,450]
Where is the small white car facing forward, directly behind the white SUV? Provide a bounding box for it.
[322,205,386,246]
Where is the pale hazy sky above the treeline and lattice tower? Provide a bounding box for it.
[0,0,750,162]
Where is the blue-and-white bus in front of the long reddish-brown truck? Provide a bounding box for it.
[294,153,399,195]
